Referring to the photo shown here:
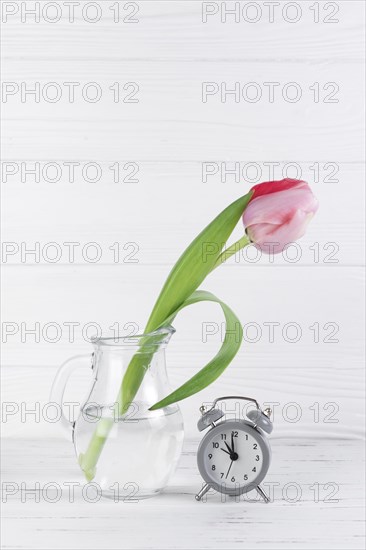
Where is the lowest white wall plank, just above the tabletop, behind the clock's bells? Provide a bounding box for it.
[2,366,365,439]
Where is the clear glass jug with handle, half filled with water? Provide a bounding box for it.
[51,326,184,500]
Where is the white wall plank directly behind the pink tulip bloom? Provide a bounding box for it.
[2,162,365,269]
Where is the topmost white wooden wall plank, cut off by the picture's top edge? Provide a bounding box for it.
[4,0,364,63]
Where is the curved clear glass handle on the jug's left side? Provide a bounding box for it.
[50,353,93,439]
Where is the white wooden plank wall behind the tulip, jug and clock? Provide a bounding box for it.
[2,0,364,437]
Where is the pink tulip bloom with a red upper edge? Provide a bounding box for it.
[243,179,318,254]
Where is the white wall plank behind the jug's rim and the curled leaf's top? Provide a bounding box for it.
[3,264,364,369]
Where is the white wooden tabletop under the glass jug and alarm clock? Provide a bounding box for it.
[2,439,364,550]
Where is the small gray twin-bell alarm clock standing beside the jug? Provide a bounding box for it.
[196,396,273,502]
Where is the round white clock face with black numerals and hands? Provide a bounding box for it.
[198,421,270,494]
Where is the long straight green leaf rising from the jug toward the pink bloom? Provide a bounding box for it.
[145,191,253,333]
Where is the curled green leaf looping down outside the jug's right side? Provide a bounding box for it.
[150,290,243,411]
